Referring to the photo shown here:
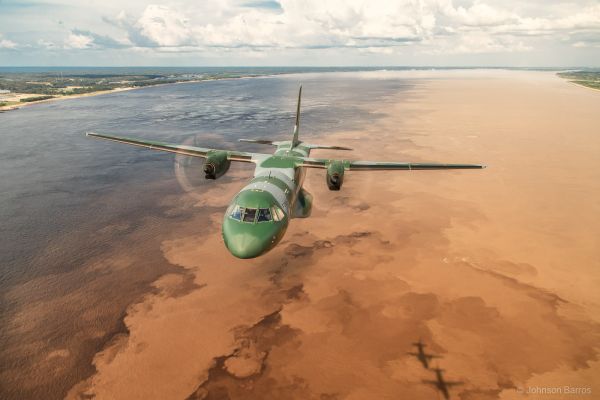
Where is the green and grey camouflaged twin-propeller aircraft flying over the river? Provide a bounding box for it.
[86,86,483,258]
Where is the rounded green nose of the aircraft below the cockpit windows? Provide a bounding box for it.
[223,218,279,258]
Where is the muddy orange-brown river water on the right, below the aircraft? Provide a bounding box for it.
[58,70,600,399]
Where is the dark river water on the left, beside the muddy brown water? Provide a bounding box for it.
[0,72,412,398]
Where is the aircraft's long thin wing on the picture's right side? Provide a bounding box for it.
[301,157,485,171]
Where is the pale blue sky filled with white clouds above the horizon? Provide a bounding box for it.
[0,0,600,67]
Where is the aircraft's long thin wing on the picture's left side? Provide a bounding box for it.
[86,132,255,162]
